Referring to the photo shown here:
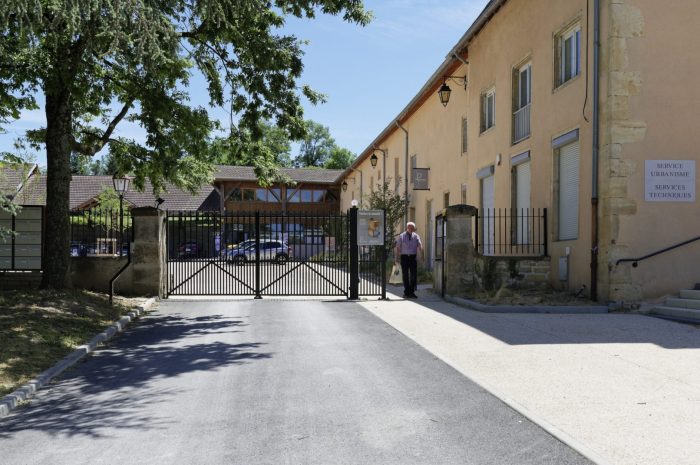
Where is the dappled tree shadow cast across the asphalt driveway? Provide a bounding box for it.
[0,315,273,438]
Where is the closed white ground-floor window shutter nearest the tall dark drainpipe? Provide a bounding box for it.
[559,141,580,240]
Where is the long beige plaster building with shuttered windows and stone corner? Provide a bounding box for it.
[341,0,700,301]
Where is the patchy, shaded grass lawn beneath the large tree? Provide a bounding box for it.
[0,290,145,397]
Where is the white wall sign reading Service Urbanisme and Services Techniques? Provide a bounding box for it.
[644,160,695,202]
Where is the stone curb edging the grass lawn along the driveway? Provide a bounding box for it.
[0,298,156,418]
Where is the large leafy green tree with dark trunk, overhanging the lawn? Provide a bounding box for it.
[0,0,370,288]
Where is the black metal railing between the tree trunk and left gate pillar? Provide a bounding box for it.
[70,207,133,257]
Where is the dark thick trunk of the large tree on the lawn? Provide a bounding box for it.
[41,87,73,289]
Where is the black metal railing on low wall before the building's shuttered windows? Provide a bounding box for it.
[474,208,548,257]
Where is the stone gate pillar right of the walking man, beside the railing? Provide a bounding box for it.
[433,205,478,295]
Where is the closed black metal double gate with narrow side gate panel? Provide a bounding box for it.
[167,211,386,298]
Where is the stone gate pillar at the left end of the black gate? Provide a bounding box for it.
[131,207,167,297]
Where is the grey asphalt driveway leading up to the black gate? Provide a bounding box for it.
[0,299,590,465]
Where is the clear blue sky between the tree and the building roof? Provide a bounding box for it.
[0,0,487,165]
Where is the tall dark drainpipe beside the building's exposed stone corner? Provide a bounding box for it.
[591,0,600,300]
